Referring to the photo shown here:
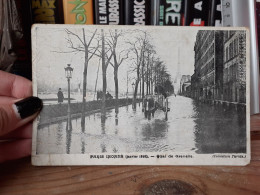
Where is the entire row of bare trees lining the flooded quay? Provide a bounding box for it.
[62,28,173,131]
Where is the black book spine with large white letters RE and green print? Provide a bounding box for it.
[157,0,184,26]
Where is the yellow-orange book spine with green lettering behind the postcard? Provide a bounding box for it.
[63,0,94,24]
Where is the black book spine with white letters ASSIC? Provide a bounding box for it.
[124,0,151,25]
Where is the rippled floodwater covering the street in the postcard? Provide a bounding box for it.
[37,96,246,154]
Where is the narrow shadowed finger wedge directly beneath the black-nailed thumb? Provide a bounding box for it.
[0,123,32,140]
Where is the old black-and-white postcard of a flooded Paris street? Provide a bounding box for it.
[32,24,250,165]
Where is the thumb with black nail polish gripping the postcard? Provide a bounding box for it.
[0,97,42,135]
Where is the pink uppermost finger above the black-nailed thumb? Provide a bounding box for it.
[0,70,32,98]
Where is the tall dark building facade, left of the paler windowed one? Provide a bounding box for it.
[191,30,224,100]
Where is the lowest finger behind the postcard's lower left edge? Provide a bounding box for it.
[0,139,32,163]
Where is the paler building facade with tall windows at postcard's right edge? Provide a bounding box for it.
[223,31,246,103]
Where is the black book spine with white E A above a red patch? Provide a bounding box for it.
[184,0,211,26]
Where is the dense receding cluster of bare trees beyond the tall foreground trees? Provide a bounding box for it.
[128,32,174,108]
